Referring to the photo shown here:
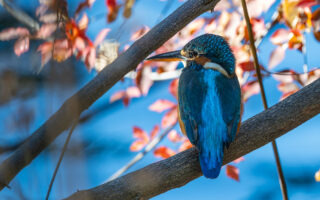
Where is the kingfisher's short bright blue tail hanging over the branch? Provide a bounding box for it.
[199,148,223,178]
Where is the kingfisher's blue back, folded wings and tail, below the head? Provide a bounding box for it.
[178,68,241,178]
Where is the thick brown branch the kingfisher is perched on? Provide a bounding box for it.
[67,79,320,200]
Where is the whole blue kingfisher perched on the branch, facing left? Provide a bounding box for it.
[147,34,241,179]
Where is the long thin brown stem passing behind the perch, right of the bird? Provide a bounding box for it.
[241,0,288,200]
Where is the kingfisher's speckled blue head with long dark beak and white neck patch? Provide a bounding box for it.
[147,34,235,77]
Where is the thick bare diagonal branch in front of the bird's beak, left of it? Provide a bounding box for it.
[0,0,219,189]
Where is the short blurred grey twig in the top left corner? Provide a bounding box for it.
[0,0,40,31]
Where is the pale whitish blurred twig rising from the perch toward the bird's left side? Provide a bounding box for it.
[106,122,177,182]
